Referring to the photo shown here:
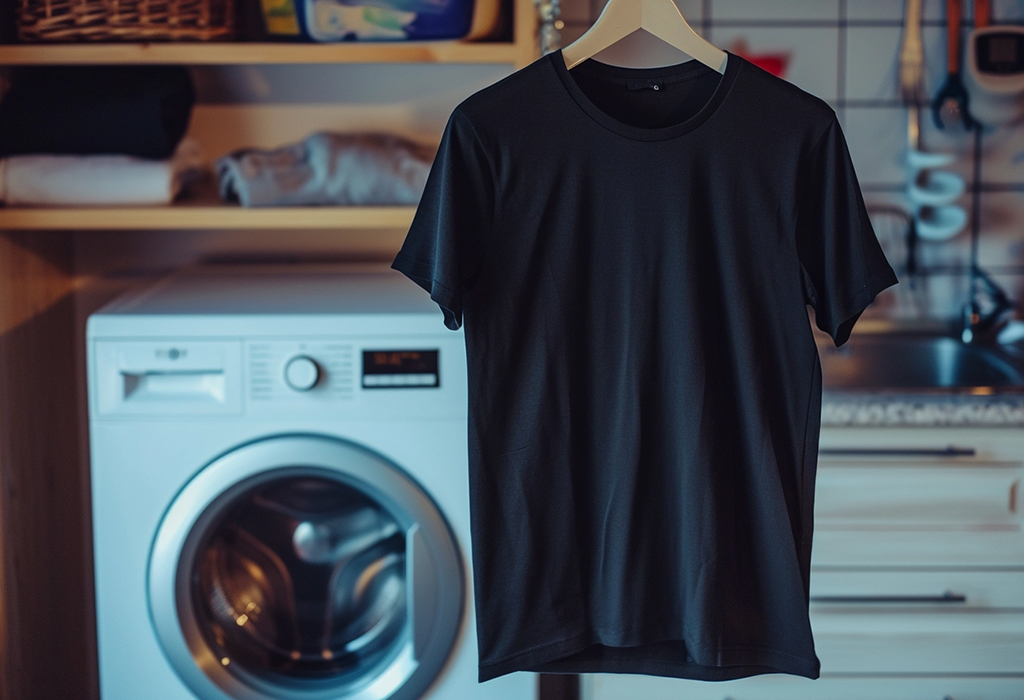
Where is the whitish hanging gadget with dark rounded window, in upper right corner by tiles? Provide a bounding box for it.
[964,0,1024,126]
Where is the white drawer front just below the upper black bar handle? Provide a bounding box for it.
[814,460,1024,526]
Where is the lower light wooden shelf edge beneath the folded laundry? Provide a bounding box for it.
[0,206,416,230]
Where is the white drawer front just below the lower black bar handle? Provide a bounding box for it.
[811,608,1024,675]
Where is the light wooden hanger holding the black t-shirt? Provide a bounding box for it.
[562,0,729,74]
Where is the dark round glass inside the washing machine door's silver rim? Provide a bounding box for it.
[191,476,408,685]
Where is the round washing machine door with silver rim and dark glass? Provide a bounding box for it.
[148,435,465,700]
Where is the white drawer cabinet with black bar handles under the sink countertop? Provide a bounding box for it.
[582,428,1024,700]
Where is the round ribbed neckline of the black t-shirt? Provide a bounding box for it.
[547,49,742,141]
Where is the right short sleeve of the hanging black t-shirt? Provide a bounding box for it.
[797,115,898,347]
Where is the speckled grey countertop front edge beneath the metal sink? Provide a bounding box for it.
[821,390,1024,428]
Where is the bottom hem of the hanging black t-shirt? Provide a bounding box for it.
[479,633,821,683]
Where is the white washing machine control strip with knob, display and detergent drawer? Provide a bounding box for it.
[93,334,467,420]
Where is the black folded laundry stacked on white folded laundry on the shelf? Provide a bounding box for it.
[0,65,203,206]
